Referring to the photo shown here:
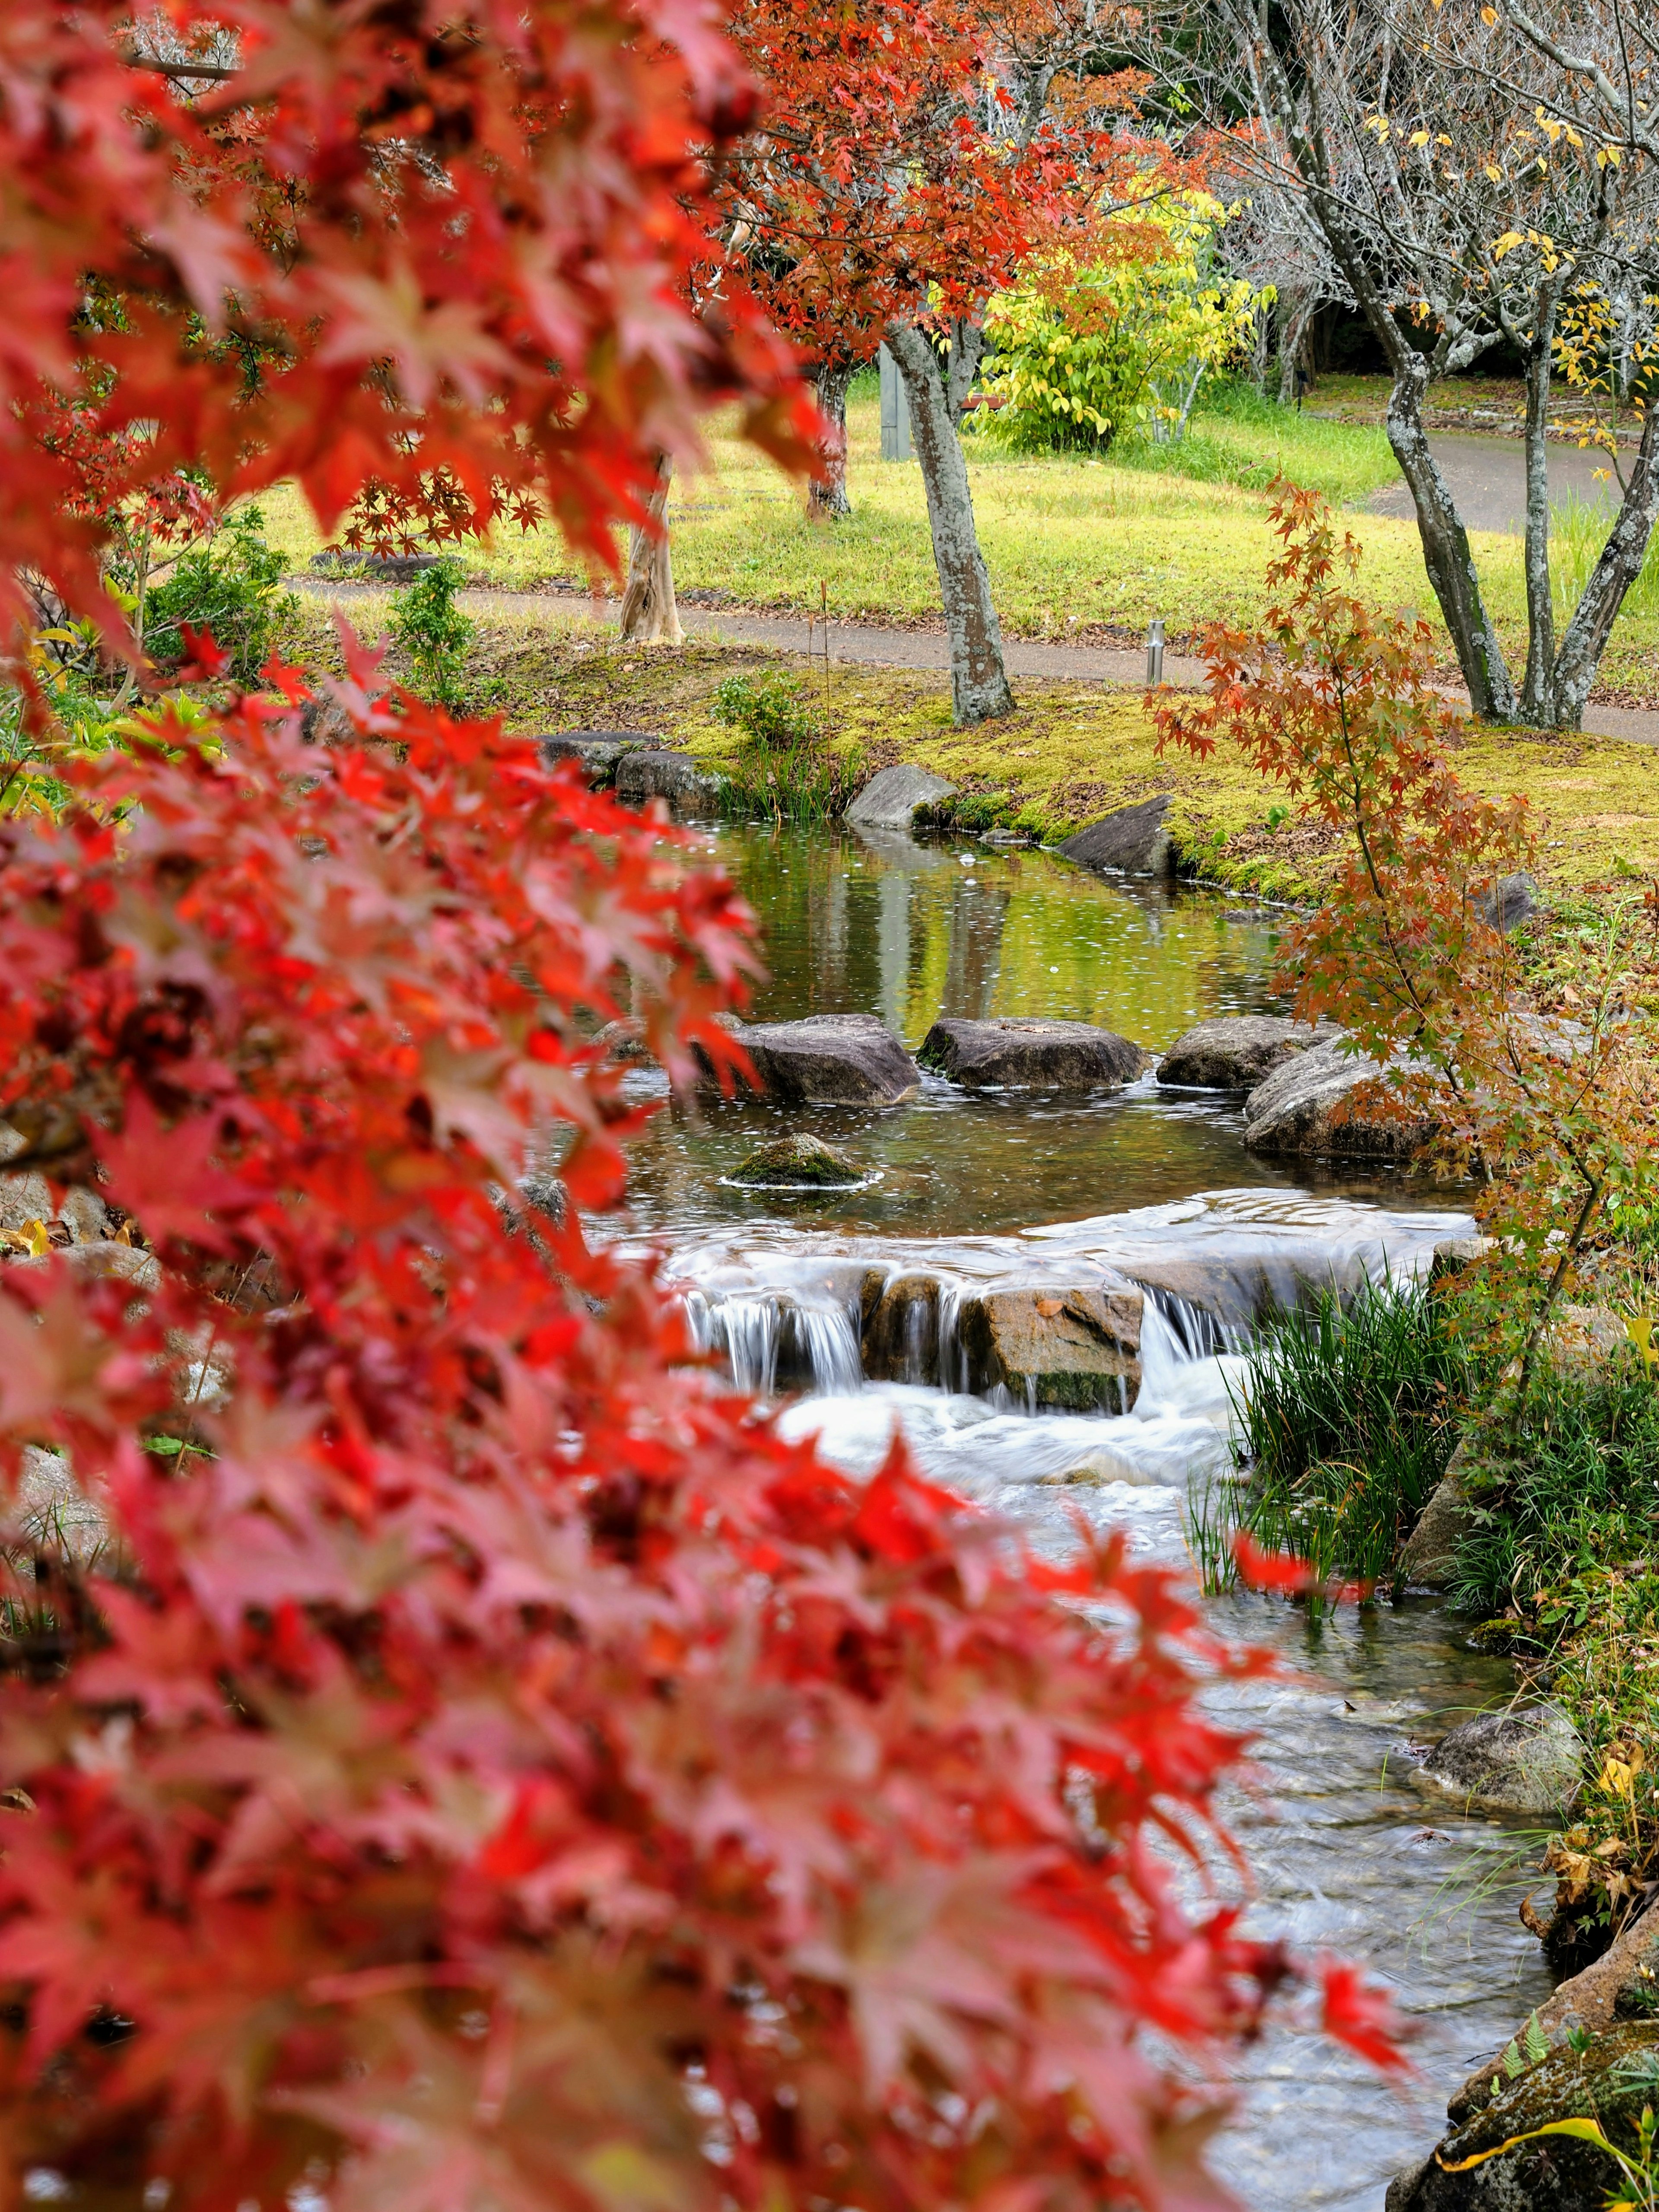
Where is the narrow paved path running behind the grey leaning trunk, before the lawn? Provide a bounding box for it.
[290,579,1659,745]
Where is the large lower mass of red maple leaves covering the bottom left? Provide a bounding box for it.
[0,657,1407,2212]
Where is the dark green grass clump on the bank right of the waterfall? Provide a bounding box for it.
[1190,1281,1478,1588]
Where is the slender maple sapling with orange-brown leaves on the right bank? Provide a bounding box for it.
[1150,486,1659,1402]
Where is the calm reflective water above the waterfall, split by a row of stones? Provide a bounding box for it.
[628,830,1468,1239]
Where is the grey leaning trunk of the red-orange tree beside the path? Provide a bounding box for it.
[887,323,1013,723]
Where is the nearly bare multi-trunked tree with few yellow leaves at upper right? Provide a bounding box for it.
[1183,0,1659,728]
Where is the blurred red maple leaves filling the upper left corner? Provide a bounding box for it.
[0,0,812,659]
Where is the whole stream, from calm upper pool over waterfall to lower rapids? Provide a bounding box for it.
[613,827,1551,2212]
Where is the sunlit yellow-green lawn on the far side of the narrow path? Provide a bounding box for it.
[261,383,1659,697]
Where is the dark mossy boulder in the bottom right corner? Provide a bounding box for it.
[1387,2020,1659,2212]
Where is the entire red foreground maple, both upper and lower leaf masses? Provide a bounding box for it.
[0,0,1394,2212]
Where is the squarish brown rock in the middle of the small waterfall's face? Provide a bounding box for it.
[958,1285,1144,1414]
